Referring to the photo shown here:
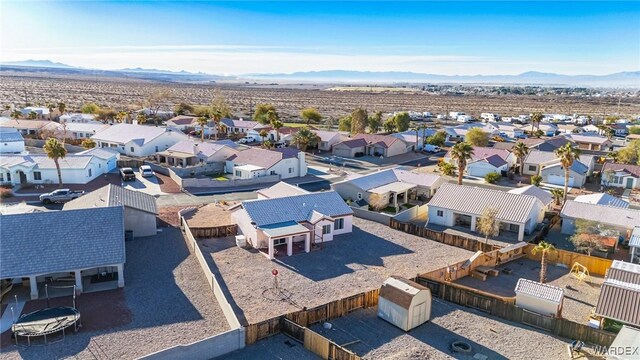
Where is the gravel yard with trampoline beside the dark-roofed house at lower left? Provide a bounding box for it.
[2,228,229,359]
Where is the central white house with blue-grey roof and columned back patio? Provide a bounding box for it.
[231,191,353,260]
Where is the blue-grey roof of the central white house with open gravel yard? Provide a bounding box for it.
[242,191,353,226]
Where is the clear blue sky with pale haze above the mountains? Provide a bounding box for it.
[0,1,640,75]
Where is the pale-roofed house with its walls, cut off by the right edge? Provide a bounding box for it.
[560,200,640,239]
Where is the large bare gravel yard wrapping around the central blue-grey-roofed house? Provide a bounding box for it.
[199,218,473,323]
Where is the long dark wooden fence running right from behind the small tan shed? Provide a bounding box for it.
[416,277,616,346]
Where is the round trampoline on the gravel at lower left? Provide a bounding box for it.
[11,306,80,345]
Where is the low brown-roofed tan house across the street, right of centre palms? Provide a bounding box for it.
[332,134,415,157]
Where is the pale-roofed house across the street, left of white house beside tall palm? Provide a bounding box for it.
[155,140,238,170]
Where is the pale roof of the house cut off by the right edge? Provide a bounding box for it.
[560,200,640,229]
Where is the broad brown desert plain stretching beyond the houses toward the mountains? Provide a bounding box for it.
[0,73,640,119]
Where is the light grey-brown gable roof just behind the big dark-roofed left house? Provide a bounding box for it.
[64,184,158,214]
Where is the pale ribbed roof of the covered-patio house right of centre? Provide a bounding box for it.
[429,183,538,223]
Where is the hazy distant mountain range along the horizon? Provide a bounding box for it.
[0,60,640,88]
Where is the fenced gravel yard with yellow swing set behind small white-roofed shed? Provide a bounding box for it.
[456,259,604,324]
